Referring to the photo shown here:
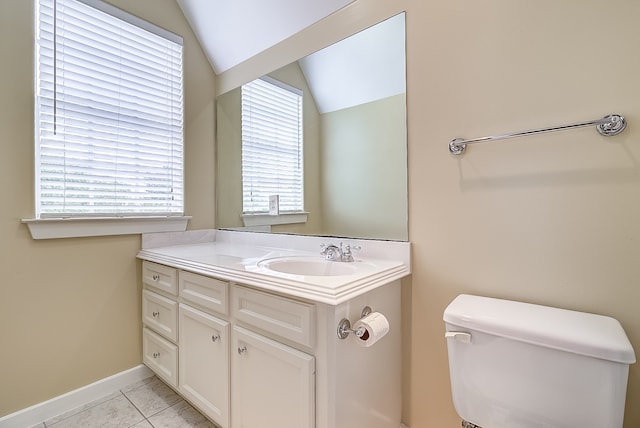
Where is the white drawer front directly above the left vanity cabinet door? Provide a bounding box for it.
[178,272,229,315]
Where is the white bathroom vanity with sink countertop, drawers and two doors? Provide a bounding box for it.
[138,230,410,428]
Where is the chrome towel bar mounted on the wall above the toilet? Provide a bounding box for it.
[449,114,627,155]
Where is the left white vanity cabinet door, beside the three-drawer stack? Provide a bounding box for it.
[178,304,230,428]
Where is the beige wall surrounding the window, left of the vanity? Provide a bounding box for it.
[0,0,215,416]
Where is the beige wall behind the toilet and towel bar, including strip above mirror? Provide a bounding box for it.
[219,0,640,428]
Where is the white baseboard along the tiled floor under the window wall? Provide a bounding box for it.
[0,364,153,428]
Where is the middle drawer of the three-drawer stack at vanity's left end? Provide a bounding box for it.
[142,290,178,342]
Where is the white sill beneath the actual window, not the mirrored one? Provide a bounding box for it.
[22,216,191,239]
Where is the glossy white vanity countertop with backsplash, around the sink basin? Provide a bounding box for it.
[138,231,411,305]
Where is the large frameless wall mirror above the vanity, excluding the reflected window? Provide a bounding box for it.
[216,13,408,241]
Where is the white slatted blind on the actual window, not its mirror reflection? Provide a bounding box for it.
[36,0,184,218]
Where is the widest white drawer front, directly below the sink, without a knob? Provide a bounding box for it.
[233,286,316,347]
